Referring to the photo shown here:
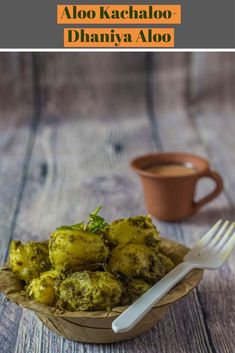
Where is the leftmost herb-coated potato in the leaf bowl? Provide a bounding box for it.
[9,240,51,282]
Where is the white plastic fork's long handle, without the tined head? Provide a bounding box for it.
[112,261,194,333]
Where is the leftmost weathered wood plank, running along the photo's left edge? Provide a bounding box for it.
[0,53,36,352]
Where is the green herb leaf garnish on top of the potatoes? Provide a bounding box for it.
[57,206,108,233]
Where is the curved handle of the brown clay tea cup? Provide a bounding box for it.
[192,169,223,214]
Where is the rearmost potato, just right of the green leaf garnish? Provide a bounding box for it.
[106,216,160,248]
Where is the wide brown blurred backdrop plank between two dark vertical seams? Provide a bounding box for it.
[36,52,145,119]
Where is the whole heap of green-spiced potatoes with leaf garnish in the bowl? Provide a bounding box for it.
[8,207,174,311]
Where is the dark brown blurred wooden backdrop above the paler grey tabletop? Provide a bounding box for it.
[0,52,235,124]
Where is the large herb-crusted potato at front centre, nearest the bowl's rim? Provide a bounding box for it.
[58,271,123,311]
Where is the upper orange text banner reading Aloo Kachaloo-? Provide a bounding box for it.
[57,5,181,24]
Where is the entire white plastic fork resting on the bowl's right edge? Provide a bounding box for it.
[112,220,235,333]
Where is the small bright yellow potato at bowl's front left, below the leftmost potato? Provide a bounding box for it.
[26,270,59,305]
